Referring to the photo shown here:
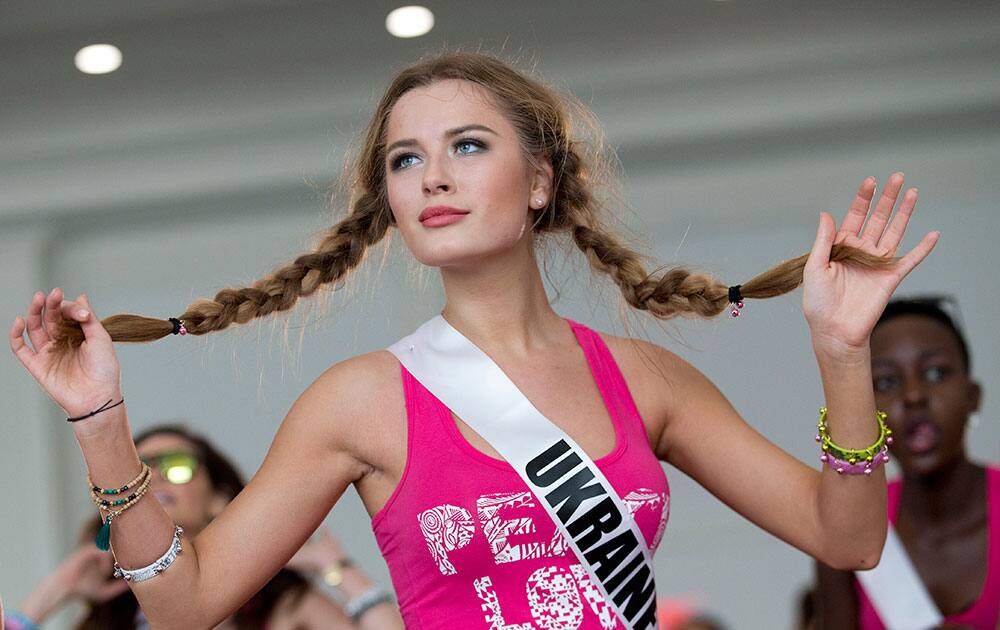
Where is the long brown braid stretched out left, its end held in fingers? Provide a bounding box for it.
[56,195,389,350]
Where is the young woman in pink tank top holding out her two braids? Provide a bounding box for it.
[10,54,937,628]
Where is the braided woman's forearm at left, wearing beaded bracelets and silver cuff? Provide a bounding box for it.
[74,405,211,628]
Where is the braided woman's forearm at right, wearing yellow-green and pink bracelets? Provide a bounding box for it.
[816,345,886,569]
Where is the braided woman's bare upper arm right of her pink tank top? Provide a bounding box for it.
[632,344,823,556]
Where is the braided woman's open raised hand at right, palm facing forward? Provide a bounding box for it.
[802,173,940,361]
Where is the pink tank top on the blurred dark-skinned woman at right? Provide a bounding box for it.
[854,467,1000,630]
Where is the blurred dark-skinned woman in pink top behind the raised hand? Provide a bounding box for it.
[817,299,1000,630]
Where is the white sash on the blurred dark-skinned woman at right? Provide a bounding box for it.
[854,525,944,630]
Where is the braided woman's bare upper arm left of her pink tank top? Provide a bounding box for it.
[182,357,377,622]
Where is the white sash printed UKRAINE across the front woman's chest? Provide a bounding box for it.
[389,315,656,630]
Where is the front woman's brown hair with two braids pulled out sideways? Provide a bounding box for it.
[57,52,892,350]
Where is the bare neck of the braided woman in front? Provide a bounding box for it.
[441,239,565,356]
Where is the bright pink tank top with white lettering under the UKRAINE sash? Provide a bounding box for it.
[372,322,670,630]
